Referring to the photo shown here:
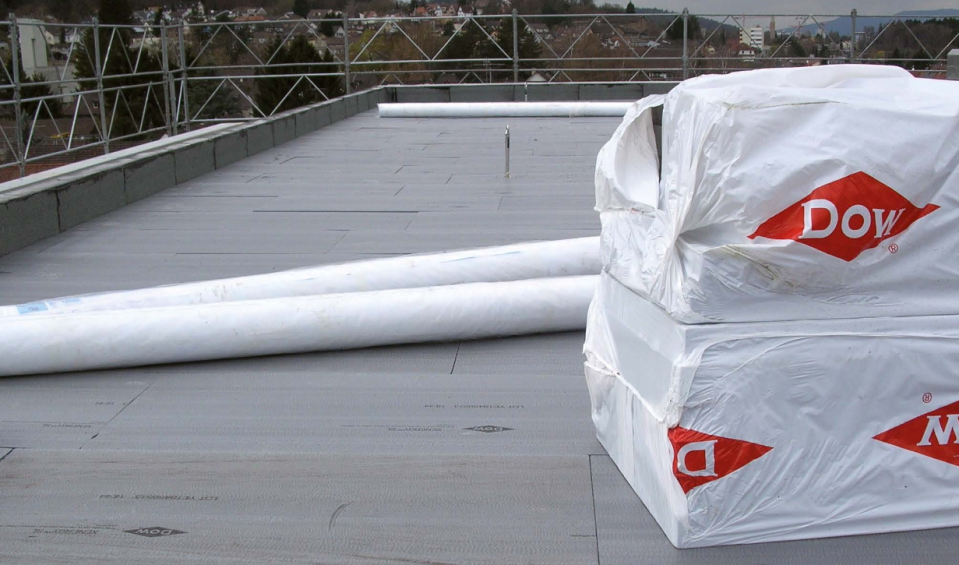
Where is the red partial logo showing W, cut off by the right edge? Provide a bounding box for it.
[873,396,959,467]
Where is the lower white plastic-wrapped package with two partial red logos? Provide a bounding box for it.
[585,274,959,547]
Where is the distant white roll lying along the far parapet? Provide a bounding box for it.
[379,102,633,118]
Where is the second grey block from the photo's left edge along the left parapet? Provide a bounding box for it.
[57,169,129,231]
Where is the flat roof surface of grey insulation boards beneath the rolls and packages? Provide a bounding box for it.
[0,112,959,565]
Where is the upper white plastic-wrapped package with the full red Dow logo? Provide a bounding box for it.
[596,65,959,322]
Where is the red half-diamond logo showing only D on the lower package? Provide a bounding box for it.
[667,427,772,494]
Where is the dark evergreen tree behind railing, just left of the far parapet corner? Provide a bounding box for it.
[254,35,343,115]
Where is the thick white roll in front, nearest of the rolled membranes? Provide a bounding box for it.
[0,275,597,376]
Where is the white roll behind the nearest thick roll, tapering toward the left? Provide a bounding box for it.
[0,237,600,320]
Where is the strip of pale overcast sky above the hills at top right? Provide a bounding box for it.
[616,0,955,15]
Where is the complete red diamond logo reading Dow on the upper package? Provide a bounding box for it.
[749,172,939,261]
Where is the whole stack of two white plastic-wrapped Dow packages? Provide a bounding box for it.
[584,66,959,547]
